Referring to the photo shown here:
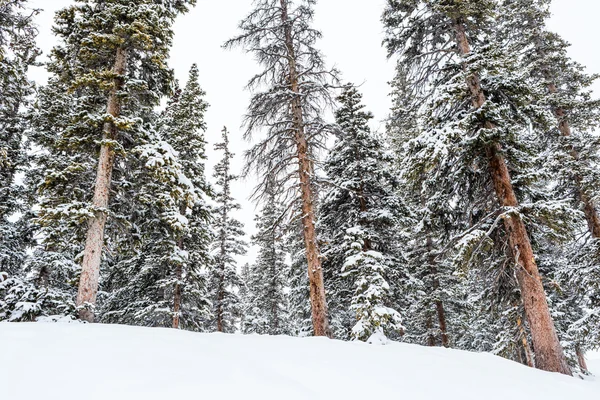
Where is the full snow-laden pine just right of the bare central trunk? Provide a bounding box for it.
[321,85,405,340]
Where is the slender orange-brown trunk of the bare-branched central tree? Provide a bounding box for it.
[280,0,331,337]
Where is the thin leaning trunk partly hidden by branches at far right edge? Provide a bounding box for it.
[547,81,600,239]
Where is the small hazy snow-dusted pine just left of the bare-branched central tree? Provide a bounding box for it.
[243,184,290,335]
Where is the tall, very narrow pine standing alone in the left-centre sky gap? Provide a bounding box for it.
[211,128,247,333]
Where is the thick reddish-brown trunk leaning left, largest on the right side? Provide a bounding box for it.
[454,19,572,375]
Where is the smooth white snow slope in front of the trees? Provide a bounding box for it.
[0,323,600,400]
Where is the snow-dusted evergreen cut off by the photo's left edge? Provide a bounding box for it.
[0,0,64,321]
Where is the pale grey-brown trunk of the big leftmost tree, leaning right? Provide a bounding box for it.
[77,48,127,322]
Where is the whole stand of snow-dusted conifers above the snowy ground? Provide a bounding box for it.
[0,0,600,375]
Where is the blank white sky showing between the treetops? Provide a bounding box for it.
[24,0,600,261]
